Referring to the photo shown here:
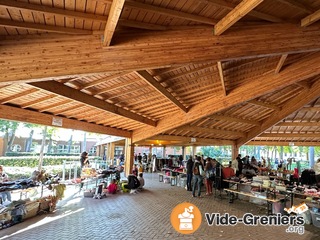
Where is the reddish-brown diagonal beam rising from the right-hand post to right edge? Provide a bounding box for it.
[237,79,320,145]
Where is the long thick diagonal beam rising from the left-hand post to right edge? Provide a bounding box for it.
[132,53,320,142]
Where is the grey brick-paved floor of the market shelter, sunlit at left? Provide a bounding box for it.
[0,173,320,240]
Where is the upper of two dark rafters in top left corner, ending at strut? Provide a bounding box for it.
[0,0,106,23]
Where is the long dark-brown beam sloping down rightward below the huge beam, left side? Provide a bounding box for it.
[30,81,156,126]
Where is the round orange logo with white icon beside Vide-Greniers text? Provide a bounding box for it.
[170,202,202,234]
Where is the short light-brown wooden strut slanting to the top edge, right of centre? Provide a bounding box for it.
[214,0,263,36]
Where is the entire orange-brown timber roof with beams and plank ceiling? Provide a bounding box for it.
[0,0,320,147]
